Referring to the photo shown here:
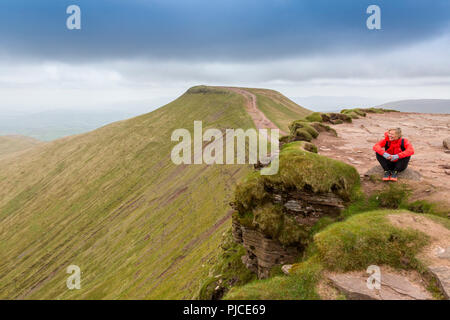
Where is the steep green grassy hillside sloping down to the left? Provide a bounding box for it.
[0,88,310,299]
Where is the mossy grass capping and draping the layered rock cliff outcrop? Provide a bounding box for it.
[234,141,360,247]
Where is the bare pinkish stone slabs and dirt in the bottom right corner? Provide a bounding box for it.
[319,213,450,300]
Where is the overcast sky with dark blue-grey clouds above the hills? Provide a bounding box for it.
[0,0,450,112]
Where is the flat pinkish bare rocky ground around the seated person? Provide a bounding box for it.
[313,112,450,208]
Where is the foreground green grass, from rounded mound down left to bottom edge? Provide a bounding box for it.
[225,209,434,300]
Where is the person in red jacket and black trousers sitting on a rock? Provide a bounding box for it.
[373,128,414,181]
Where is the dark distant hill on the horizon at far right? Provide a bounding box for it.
[377,99,450,113]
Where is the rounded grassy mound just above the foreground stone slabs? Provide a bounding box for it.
[314,210,427,271]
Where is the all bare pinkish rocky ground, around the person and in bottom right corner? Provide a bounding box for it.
[313,112,450,299]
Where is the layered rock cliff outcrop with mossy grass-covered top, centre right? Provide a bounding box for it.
[232,141,359,279]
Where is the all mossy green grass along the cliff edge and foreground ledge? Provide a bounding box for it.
[210,109,450,300]
